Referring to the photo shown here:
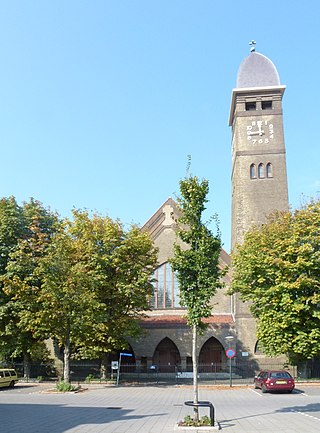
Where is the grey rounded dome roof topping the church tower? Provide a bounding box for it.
[237,51,280,88]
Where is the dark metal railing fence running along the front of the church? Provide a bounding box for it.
[8,361,320,385]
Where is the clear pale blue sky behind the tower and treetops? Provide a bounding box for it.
[0,0,320,251]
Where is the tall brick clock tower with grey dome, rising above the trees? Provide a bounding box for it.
[229,41,289,249]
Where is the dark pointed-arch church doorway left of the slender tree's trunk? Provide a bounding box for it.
[152,337,181,372]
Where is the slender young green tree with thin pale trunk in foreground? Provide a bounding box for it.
[170,176,223,421]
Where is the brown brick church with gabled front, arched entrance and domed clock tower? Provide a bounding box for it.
[126,42,289,372]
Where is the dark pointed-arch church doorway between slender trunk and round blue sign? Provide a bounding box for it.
[199,337,226,372]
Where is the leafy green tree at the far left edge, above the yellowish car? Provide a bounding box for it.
[0,198,58,377]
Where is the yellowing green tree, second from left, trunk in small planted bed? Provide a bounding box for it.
[25,211,104,382]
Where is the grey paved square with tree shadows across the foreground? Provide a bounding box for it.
[0,384,320,433]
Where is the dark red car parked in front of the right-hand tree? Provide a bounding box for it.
[254,370,295,392]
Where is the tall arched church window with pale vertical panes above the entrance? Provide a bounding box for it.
[150,262,181,309]
